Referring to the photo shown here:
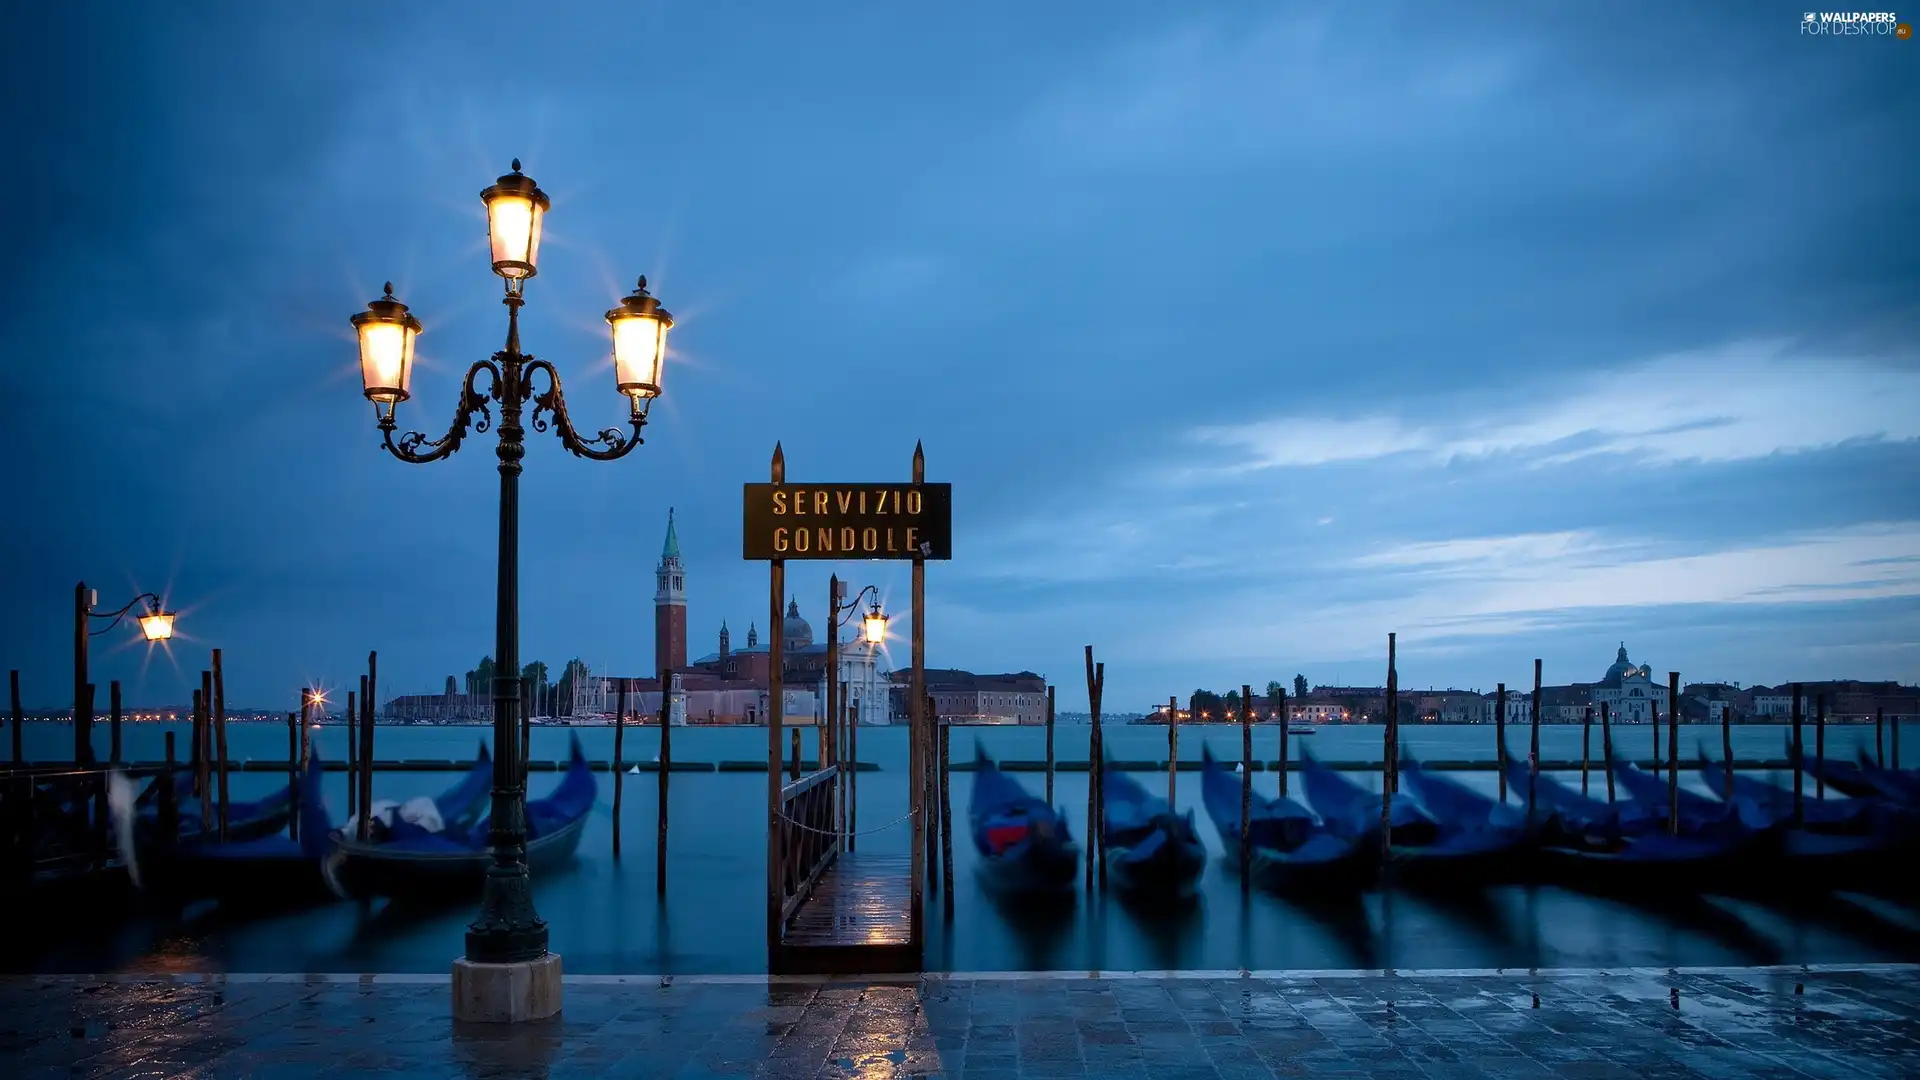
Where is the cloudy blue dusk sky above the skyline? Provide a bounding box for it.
[0,2,1920,709]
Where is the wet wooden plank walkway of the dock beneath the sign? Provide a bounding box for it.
[770,851,922,974]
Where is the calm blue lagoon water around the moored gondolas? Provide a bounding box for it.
[8,723,1920,974]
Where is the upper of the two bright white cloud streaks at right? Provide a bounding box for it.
[1171,342,1920,472]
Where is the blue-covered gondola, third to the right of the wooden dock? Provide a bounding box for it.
[1200,748,1377,899]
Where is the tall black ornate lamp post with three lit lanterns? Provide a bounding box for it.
[353,161,674,965]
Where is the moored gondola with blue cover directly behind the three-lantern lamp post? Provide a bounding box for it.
[321,734,599,899]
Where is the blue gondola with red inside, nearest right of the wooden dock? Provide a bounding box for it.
[968,742,1079,894]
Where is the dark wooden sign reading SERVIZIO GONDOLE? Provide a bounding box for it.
[741,484,952,559]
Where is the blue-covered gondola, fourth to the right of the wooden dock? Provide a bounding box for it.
[1300,753,1526,888]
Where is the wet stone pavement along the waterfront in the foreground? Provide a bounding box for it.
[0,967,1920,1080]
